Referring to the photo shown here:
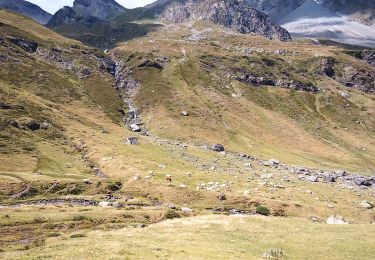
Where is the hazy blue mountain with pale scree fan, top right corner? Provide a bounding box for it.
[247,0,375,47]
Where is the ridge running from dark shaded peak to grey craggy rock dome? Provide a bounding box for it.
[48,0,290,49]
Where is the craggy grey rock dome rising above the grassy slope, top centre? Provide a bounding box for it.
[160,0,291,41]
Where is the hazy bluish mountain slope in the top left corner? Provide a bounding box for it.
[0,0,52,24]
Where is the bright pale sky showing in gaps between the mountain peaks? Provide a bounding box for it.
[27,0,155,14]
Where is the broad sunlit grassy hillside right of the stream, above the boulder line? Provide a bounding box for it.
[114,21,375,170]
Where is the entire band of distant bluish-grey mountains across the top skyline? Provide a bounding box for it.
[0,0,375,48]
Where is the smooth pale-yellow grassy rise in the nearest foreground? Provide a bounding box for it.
[0,215,375,259]
